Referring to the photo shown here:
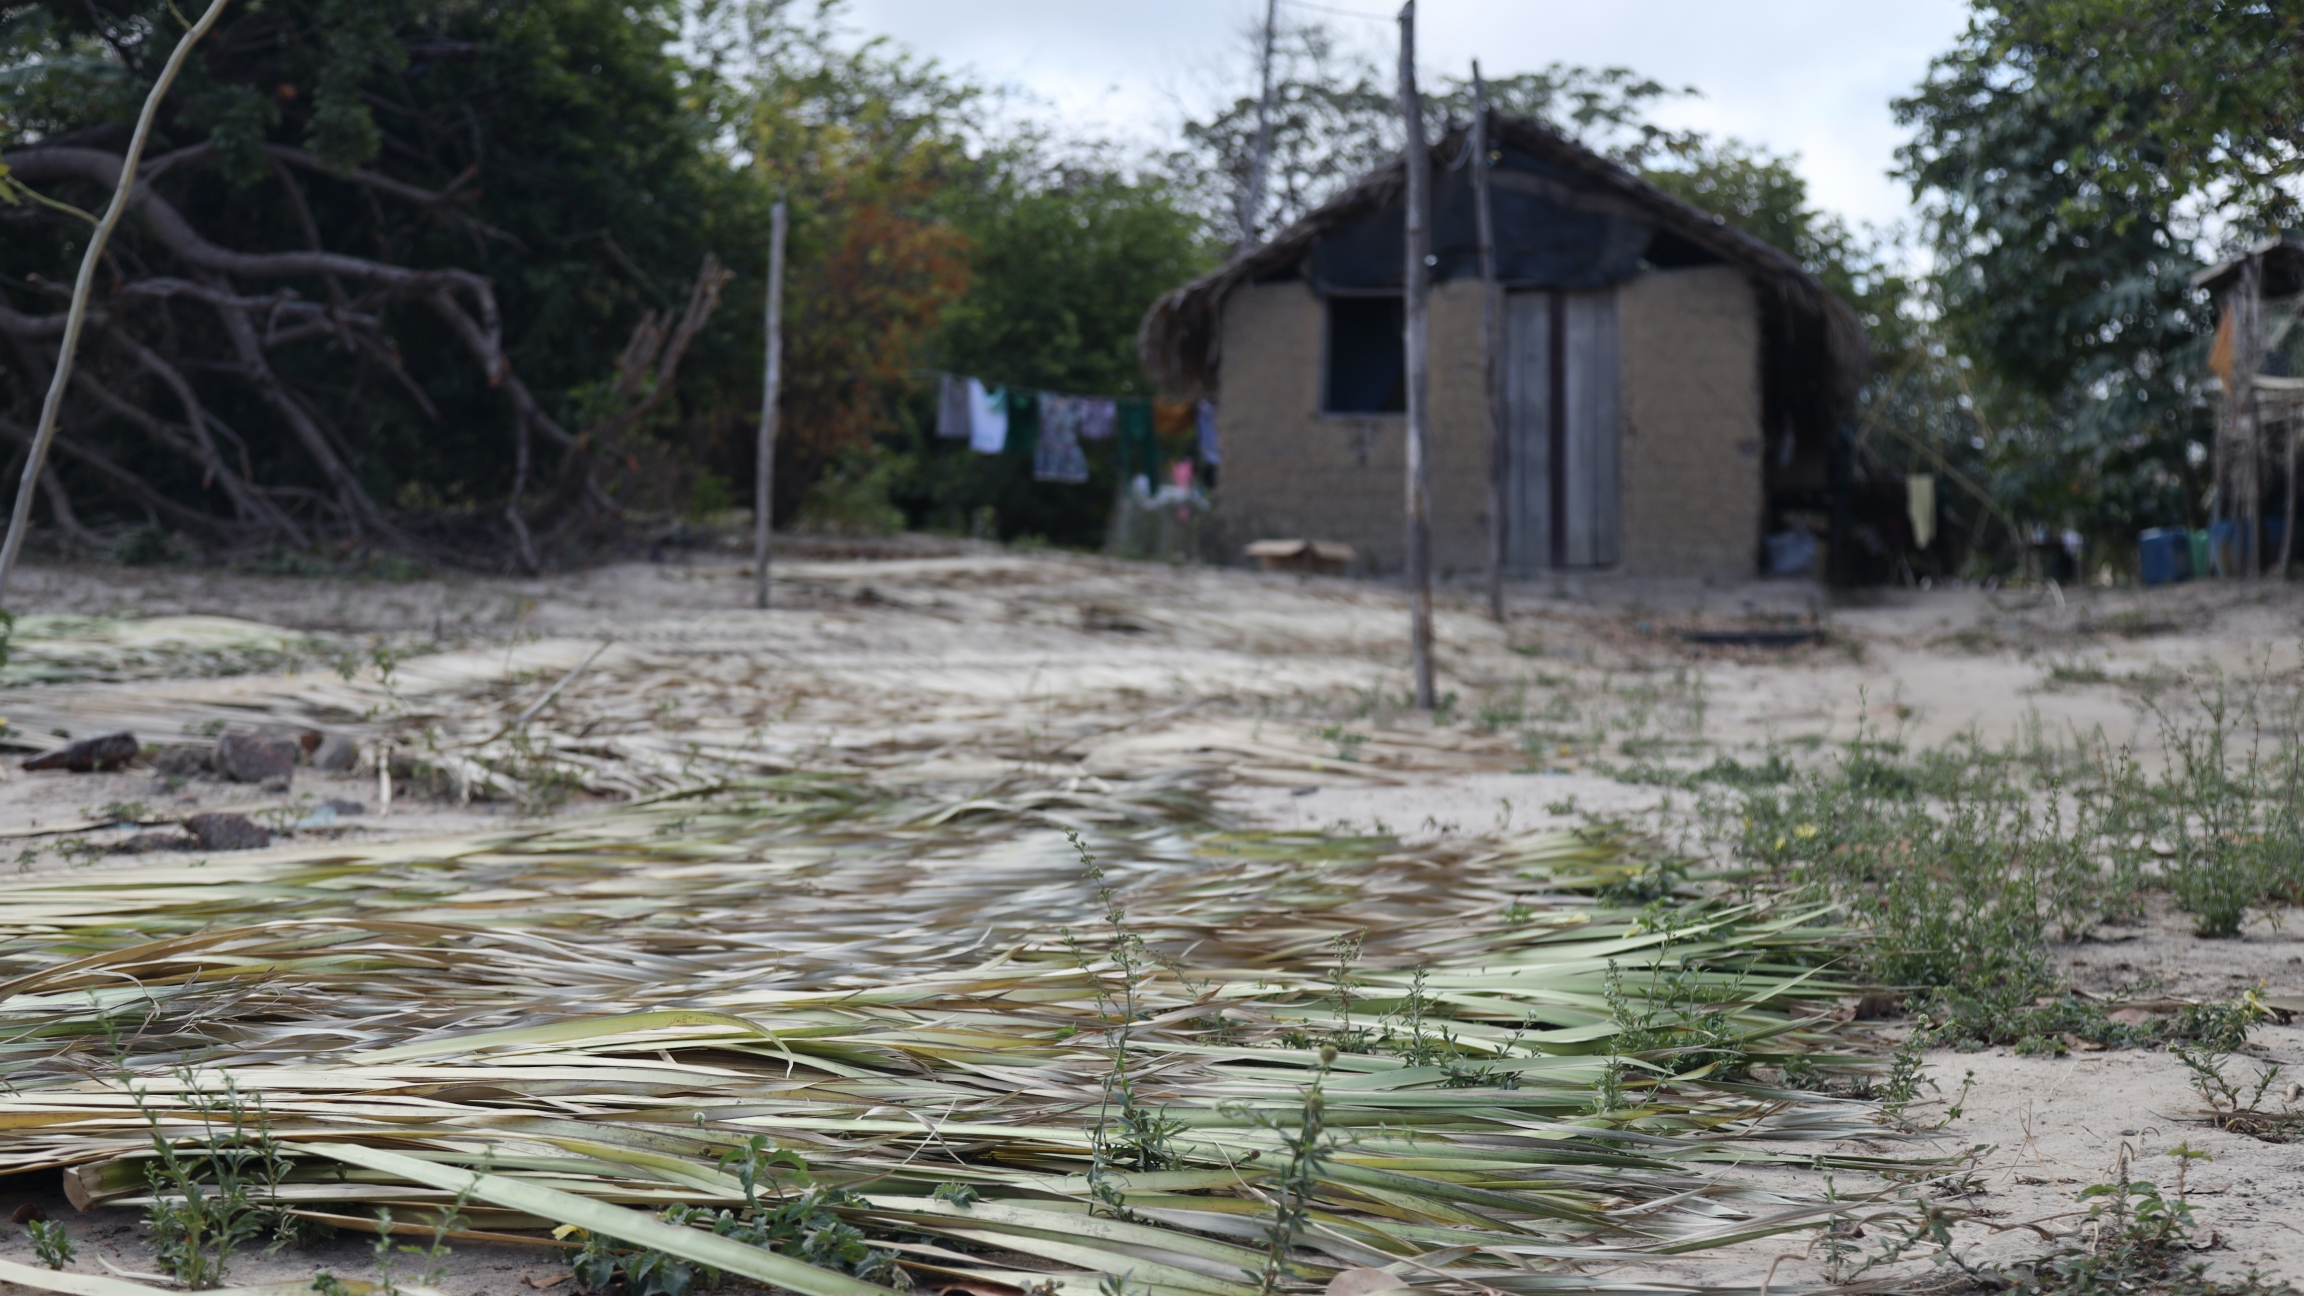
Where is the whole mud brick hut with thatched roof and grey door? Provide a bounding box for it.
[1138,115,1910,577]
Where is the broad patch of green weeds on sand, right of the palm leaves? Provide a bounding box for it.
[1675,690,2304,1054]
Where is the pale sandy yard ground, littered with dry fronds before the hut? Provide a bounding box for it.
[0,542,2304,1296]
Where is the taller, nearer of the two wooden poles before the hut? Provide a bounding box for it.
[1401,0,1438,710]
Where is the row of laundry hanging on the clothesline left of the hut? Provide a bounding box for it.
[935,374,1219,484]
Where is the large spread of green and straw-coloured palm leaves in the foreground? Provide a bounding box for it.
[0,777,1916,1296]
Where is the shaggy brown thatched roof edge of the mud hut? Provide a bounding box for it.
[1138,115,1871,417]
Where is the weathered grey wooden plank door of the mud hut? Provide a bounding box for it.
[1505,288,1622,574]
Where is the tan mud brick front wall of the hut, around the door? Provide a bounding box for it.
[1217,268,1760,577]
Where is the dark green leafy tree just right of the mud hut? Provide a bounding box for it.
[1896,7,2210,551]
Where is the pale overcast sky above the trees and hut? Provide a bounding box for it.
[848,0,1968,224]
